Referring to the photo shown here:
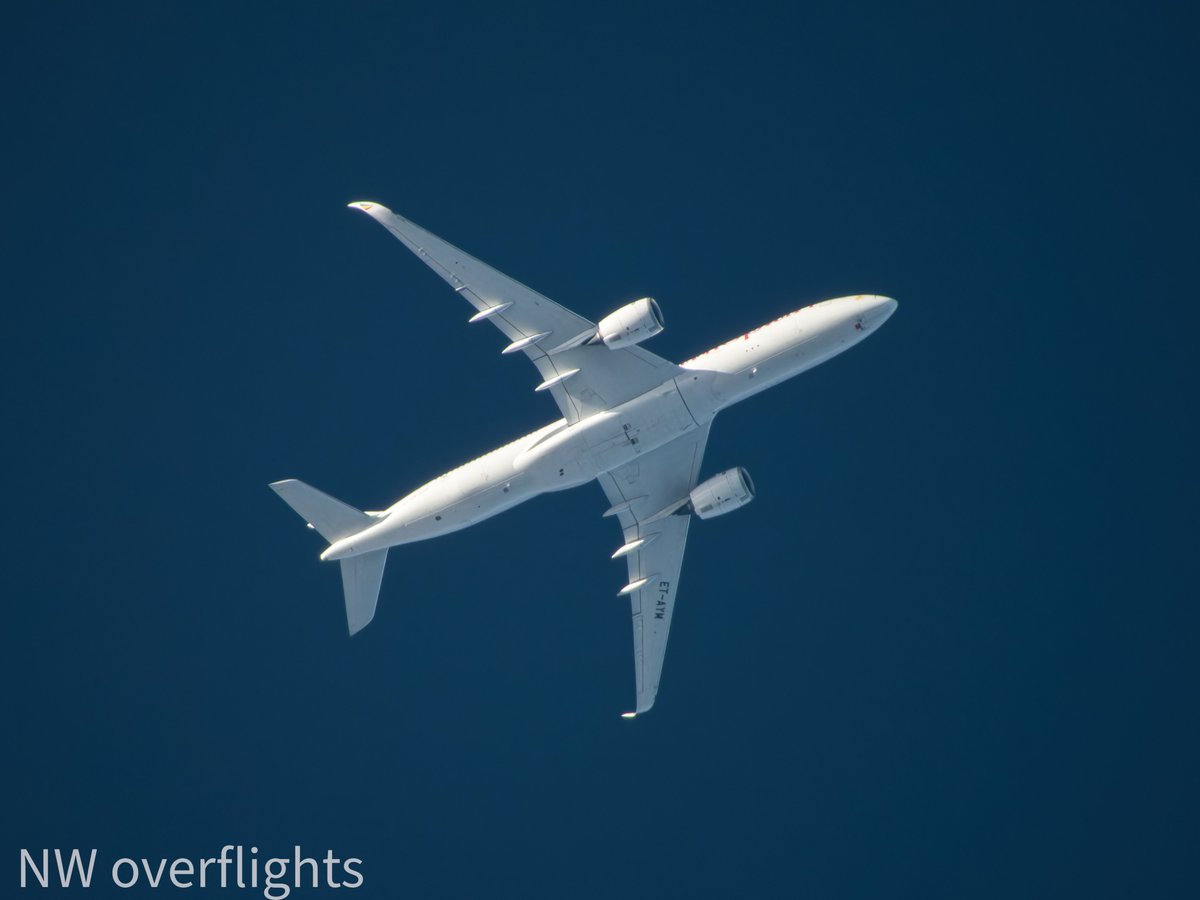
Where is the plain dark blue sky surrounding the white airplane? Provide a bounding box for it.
[0,2,1200,898]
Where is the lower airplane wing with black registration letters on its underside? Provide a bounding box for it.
[599,424,710,718]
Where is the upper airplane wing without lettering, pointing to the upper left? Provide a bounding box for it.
[349,203,682,425]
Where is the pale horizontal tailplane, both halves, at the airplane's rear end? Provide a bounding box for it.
[271,479,388,635]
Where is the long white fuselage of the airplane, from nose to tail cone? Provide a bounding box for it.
[320,294,896,559]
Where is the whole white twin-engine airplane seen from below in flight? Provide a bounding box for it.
[270,202,896,719]
